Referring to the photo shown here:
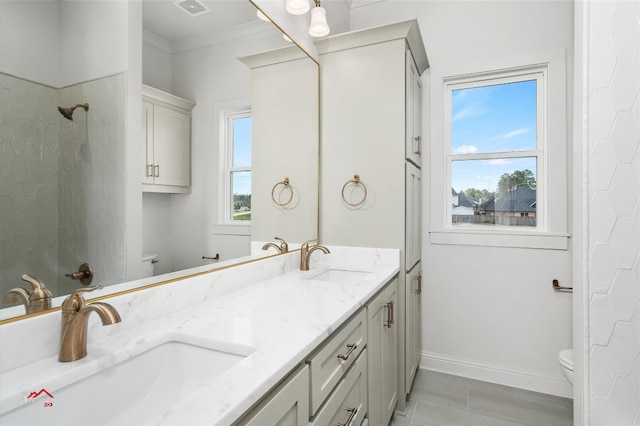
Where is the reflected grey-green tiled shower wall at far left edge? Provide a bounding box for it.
[0,73,60,295]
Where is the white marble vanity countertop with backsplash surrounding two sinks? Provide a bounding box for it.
[0,246,400,425]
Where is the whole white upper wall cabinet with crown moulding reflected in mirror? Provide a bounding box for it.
[142,85,195,193]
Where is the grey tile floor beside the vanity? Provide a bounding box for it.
[390,370,573,426]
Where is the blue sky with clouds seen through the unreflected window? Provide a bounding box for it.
[451,80,536,192]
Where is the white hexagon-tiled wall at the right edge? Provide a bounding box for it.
[585,0,640,426]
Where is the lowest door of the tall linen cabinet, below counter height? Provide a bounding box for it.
[405,263,422,393]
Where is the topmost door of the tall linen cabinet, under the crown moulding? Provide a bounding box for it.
[405,50,423,167]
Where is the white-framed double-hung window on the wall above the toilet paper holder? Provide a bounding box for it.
[445,68,547,229]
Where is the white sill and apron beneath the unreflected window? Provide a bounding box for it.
[429,229,570,250]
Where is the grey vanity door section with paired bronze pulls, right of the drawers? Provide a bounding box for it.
[367,278,398,426]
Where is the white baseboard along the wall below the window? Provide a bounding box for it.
[420,352,573,398]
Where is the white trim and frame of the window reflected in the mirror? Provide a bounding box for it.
[214,104,251,226]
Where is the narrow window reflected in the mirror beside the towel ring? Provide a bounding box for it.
[224,108,251,224]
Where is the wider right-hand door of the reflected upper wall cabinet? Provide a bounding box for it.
[153,105,191,186]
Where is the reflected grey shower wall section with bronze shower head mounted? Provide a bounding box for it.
[58,74,126,292]
